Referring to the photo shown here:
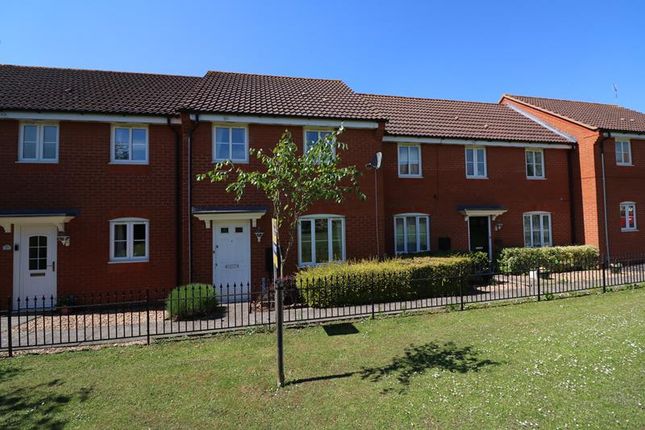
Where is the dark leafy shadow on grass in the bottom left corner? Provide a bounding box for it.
[0,379,92,430]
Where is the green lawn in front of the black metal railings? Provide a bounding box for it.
[0,289,645,429]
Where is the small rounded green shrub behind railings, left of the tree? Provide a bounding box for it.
[166,284,218,319]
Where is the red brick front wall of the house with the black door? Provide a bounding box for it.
[383,143,571,254]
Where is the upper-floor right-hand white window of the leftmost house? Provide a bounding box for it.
[110,124,148,164]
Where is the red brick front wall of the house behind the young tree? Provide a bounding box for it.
[185,122,383,288]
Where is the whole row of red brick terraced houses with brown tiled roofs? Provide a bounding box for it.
[0,65,645,306]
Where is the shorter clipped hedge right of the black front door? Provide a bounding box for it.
[498,245,599,274]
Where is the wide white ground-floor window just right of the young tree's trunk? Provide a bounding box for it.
[298,215,345,266]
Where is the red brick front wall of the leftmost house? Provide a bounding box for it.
[0,120,176,296]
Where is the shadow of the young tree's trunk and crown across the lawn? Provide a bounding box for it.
[287,342,500,393]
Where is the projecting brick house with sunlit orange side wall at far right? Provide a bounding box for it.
[500,95,645,256]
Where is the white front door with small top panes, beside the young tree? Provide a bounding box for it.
[213,221,251,303]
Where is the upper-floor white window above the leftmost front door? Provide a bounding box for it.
[18,122,58,163]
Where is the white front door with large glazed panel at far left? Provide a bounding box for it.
[13,225,58,309]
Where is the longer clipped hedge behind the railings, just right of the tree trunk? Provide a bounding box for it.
[295,255,473,307]
